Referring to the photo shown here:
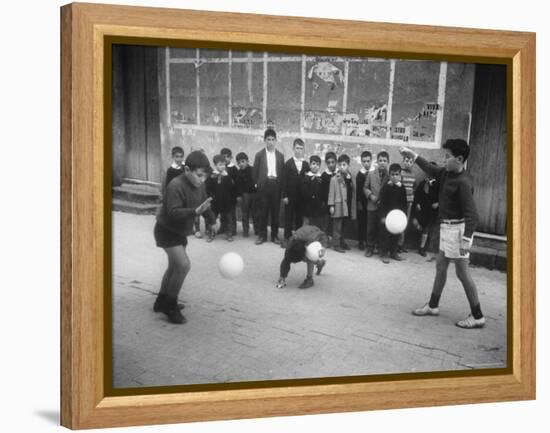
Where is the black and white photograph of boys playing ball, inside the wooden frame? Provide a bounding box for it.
[111,44,511,389]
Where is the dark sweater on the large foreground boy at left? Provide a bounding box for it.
[157,176,216,236]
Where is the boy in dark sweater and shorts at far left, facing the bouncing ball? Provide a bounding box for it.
[153,151,216,324]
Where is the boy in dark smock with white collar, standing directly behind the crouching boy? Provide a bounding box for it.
[301,155,327,230]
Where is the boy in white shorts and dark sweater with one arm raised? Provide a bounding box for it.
[400,139,485,329]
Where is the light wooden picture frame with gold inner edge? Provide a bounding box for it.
[61,3,535,429]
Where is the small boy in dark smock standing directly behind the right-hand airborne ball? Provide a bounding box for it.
[378,164,407,264]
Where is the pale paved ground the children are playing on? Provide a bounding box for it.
[113,212,506,387]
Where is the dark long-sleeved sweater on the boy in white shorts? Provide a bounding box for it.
[416,156,478,238]
